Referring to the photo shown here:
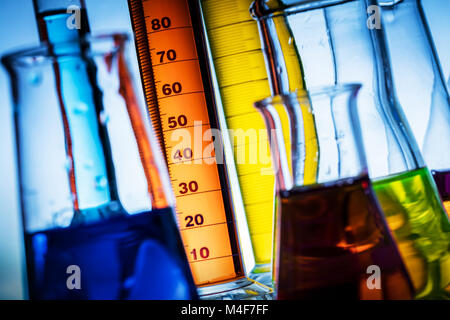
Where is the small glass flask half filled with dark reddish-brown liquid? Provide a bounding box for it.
[255,84,413,299]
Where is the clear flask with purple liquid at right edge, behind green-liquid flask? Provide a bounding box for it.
[378,0,450,213]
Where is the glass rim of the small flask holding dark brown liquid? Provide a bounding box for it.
[253,83,362,109]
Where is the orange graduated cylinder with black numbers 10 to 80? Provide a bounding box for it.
[128,0,271,299]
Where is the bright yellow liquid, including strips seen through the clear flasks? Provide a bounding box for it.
[201,0,318,266]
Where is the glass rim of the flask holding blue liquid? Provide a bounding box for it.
[1,32,129,67]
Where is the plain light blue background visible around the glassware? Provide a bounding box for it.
[0,0,450,299]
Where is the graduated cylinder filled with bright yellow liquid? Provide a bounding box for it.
[199,0,275,285]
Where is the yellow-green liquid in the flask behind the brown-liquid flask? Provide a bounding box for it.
[373,168,450,299]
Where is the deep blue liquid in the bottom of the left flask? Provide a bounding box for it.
[25,208,197,300]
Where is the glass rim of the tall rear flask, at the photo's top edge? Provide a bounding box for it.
[250,0,355,20]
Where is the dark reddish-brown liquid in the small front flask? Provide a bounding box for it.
[276,176,412,299]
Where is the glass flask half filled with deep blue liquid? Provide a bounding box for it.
[2,34,197,299]
